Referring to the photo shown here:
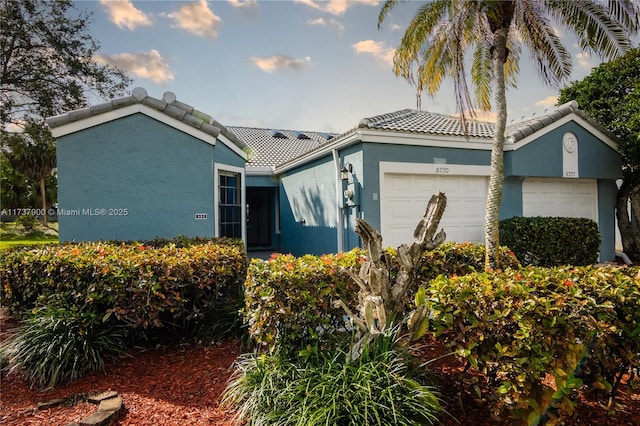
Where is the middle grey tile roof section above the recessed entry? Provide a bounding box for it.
[227,126,335,167]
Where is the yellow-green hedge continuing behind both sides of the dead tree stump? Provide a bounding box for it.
[245,243,519,352]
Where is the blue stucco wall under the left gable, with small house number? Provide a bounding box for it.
[57,114,244,241]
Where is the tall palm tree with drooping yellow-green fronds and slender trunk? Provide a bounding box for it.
[378,0,640,269]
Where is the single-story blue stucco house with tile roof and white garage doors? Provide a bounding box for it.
[47,88,621,261]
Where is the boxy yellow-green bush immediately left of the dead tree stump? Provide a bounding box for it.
[244,250,363,354]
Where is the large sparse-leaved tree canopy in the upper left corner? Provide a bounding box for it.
[0,0,130,131]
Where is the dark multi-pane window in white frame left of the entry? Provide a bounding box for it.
[218,170,242,238]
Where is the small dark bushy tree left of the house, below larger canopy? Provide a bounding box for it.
[2,122,56,226]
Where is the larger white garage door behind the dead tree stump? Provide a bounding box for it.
[380,173,488,247]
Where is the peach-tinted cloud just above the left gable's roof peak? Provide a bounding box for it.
[95,49,173,84]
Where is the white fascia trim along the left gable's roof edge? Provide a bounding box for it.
[51,103,216,147]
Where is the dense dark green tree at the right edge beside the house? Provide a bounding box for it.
[558,47,640,262]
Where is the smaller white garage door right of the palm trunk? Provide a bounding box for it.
[522,179,598,222]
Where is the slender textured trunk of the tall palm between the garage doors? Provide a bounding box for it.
[484,27,508,270]
